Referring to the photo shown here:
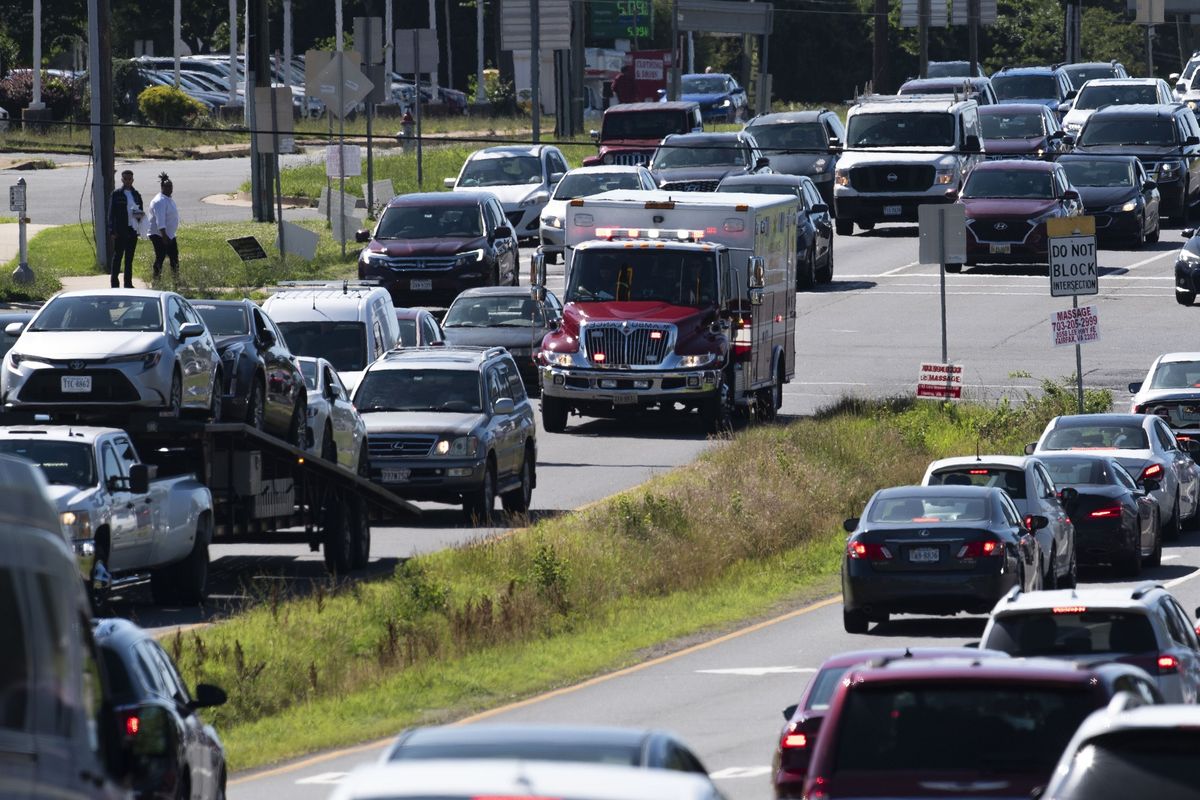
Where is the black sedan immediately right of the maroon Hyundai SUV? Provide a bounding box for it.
[1058,155,1162,247]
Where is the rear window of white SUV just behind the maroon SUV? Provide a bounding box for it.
[983,602,1158,656]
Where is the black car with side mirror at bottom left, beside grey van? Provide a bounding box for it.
[92,619,227,800]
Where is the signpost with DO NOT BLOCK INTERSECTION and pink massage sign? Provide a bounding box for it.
[1046,217,1100,414]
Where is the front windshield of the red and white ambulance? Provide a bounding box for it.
[566,248,718,307]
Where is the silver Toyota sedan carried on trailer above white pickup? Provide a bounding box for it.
[0,289,223,419]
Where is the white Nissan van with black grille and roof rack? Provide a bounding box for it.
[833,95,983,236]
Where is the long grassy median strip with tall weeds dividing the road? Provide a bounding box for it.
[164,383,1111,769]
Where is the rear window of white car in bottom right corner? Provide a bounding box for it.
[1055,726,1200,800]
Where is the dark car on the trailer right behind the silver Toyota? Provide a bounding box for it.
[193,300,308,447]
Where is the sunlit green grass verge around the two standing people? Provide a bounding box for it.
[0,219,359,300]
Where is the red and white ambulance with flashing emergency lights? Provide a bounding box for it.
[534,191,799,432]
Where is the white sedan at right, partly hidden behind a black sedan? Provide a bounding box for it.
[1025,414,1200,539]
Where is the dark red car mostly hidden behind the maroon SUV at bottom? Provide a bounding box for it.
[772,648,1008,800]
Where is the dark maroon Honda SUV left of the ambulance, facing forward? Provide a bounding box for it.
[358,191,520,307]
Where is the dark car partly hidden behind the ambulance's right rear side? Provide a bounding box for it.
[716,174,833,289]
